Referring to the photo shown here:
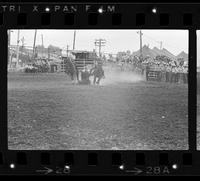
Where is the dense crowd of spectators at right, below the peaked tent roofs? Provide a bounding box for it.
[116,55,188,83]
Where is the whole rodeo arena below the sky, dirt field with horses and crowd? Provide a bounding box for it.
[8,30,188,150]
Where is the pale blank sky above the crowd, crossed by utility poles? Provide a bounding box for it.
[11,29,188,55]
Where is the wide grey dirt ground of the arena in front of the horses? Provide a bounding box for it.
[8,70,188,150]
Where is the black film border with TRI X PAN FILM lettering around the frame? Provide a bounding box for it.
[0,3,200,175]
